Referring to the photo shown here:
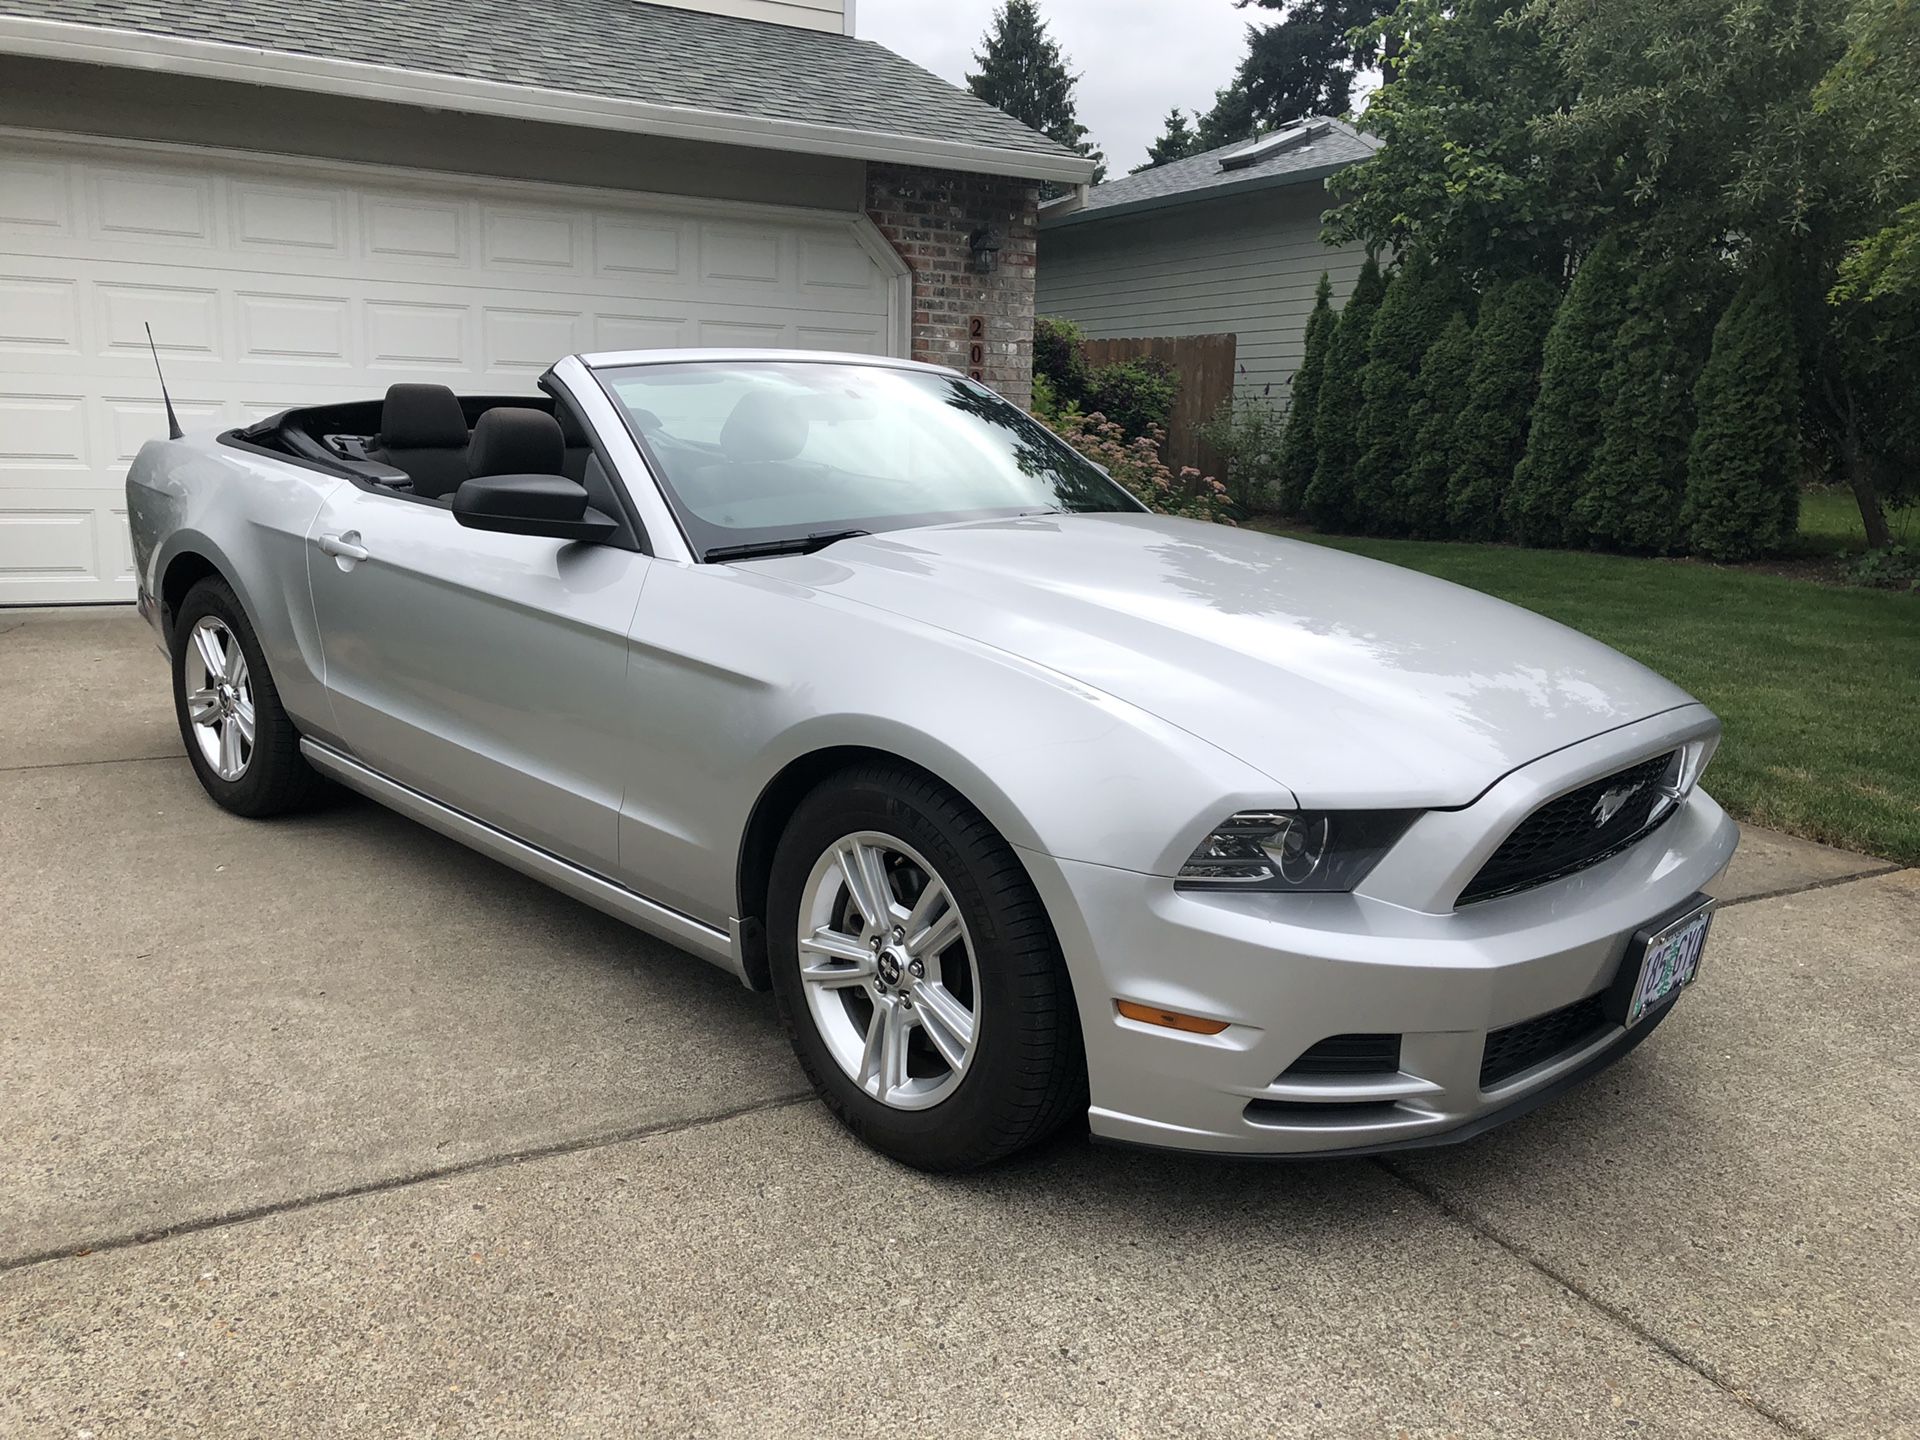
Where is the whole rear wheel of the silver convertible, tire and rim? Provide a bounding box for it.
[173,576,324,818]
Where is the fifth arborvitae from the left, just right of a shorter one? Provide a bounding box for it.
[1446,275,1559,540]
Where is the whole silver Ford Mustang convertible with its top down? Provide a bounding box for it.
[127,351,1736,1169]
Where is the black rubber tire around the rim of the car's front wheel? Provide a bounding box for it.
[768,764,1087,1171]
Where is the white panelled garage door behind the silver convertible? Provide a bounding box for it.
[0,140,904,605]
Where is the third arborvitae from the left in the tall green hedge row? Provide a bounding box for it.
[1352,257,1452,534]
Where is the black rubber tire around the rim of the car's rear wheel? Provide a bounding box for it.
[171,576,326,820]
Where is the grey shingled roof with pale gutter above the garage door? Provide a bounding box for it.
[0,0,1092,182]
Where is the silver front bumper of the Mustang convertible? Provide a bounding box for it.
[1025,707,1738,1156]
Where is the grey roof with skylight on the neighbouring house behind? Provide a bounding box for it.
[1041,115,1380,230]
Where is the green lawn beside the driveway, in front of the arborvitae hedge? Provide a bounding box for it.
[1259,533,1920,864]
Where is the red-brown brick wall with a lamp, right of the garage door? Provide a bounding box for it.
[866,165,1041,407]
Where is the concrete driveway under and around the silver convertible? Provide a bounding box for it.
[0,611,1920,1440]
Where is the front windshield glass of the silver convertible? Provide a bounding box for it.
[599,361,1140,555]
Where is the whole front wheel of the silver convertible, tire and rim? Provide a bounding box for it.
[768,766,1087,1169]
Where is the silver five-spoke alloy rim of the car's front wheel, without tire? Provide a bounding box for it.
[799,831,979,1110]
